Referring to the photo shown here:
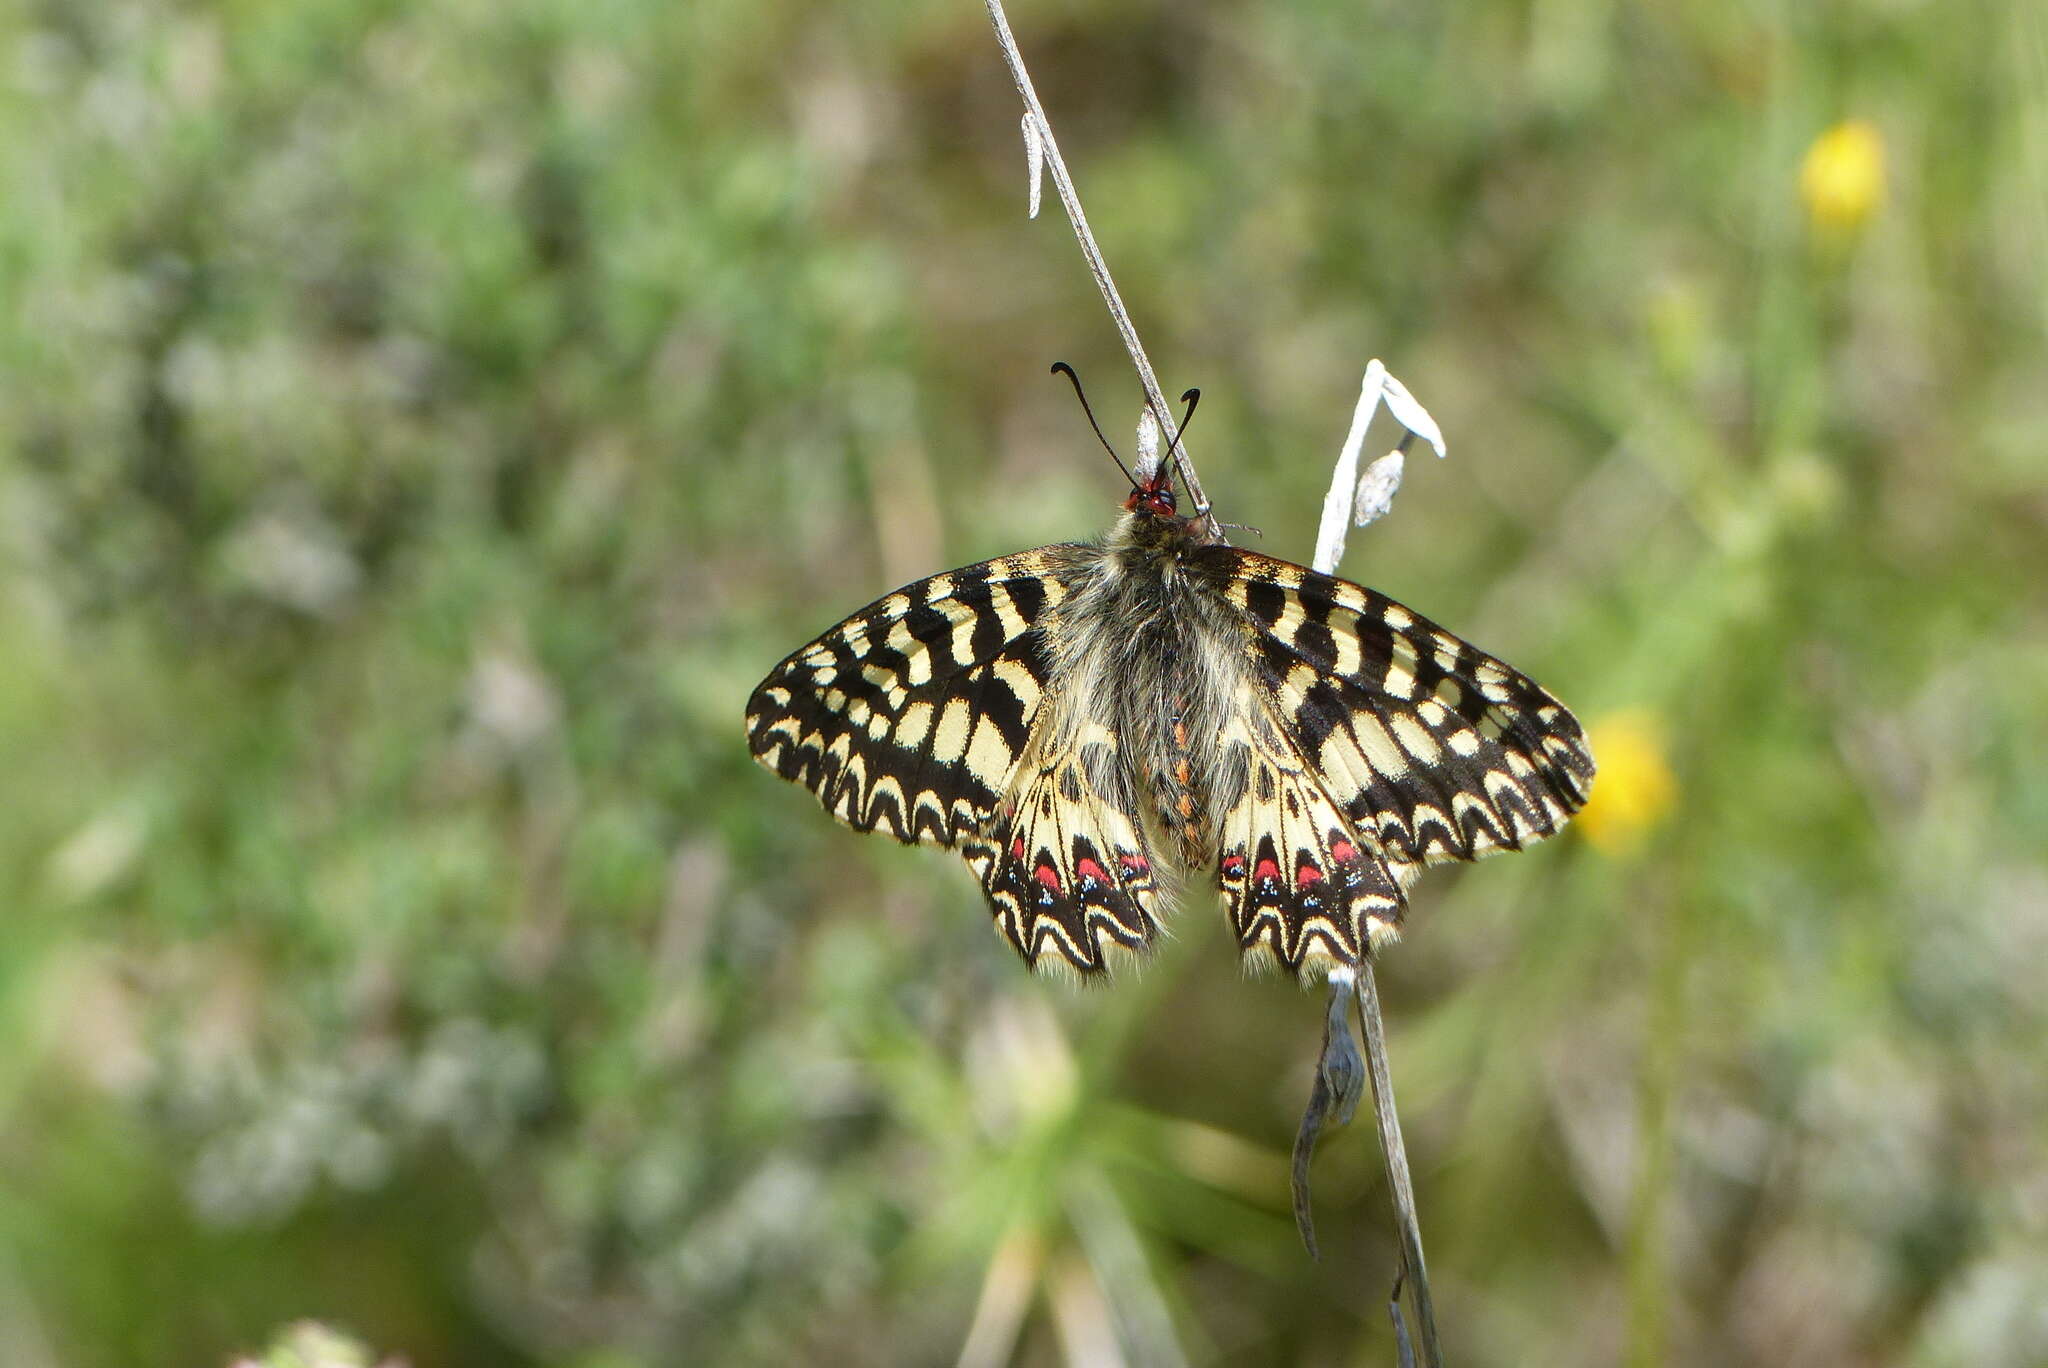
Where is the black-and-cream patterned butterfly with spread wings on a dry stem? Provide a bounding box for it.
[748,387,1593,979]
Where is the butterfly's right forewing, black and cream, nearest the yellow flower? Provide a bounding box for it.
[1227,551,1593,864]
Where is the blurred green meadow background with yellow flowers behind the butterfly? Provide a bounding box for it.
[0,0,2048,1368]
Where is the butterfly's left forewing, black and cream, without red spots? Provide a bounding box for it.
[748,547,1069,846]
